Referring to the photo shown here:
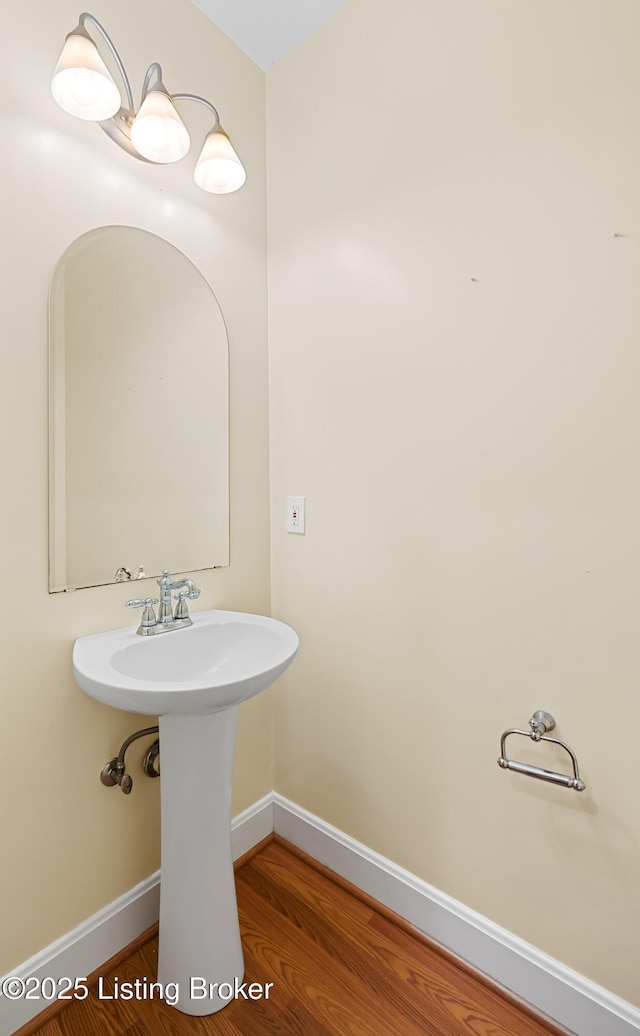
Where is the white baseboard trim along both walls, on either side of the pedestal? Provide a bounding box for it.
[0,793,640,1036]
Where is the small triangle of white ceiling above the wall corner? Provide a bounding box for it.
[193,0,347,71]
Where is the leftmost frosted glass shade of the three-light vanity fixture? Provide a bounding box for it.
[51,32,122,122]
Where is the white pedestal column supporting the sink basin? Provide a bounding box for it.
[157,706,244,1015]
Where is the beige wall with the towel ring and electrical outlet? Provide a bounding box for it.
[267,0,640,1005]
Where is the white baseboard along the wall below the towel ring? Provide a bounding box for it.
[273,794,640,1036]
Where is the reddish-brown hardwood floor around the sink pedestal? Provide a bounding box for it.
[20,838,560,1036]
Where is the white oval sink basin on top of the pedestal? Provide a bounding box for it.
[72,610,298,716]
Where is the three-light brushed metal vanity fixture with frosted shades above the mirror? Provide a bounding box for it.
[51,11,246,194]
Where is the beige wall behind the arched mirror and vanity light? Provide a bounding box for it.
[0,0,272,974]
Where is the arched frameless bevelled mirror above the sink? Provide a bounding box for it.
[49,227,229,597]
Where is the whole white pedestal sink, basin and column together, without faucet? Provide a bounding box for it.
[72,610,298,1015]
